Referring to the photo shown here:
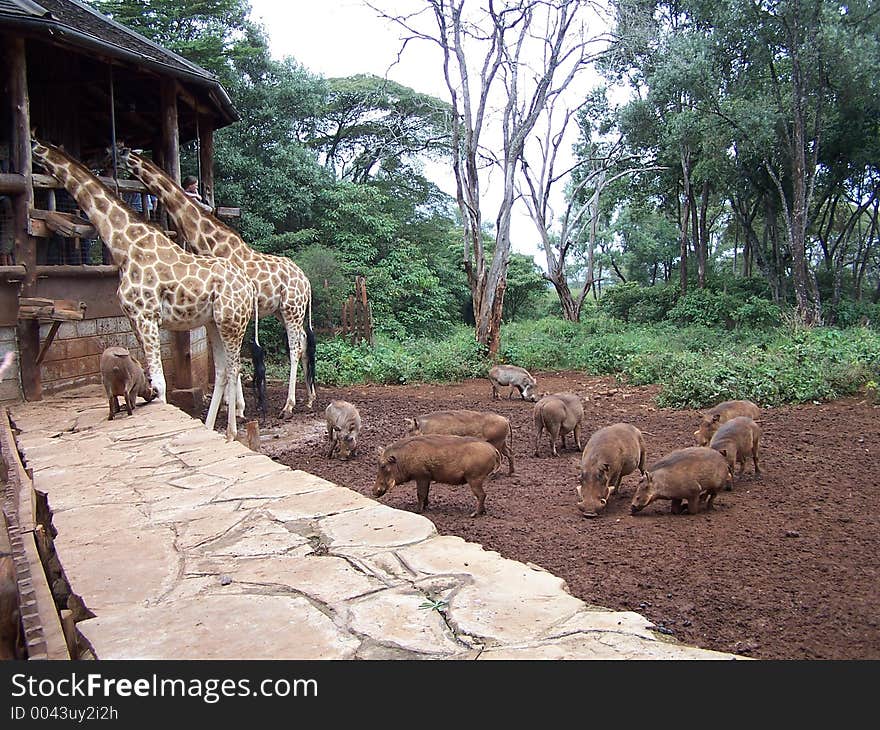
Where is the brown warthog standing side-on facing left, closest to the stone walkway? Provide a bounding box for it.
[373,434,501,517]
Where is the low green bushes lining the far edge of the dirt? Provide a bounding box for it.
[261,312,880,408]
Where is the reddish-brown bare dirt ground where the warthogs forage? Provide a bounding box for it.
[237,372,880,659]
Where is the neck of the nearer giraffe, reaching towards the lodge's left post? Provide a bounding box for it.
[34,145,137,266]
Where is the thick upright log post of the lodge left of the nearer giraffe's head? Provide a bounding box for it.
[3,35,43,401]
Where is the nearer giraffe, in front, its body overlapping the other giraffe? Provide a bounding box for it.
[32,139,257,441]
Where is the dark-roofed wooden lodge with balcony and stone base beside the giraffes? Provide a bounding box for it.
[0,0,238,409]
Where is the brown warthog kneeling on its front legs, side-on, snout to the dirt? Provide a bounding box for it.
[630,446,731,515]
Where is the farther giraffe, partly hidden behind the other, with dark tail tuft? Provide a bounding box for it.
[118,145,315,418]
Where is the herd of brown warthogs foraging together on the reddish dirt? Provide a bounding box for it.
[326,365,761,517]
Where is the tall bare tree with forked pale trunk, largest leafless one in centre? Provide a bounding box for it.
[374,0,597,355]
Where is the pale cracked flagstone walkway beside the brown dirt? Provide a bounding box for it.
[10,387,736,659]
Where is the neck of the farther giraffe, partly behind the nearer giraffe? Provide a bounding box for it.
[128,152,235,257]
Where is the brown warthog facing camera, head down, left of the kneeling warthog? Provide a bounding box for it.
[577,423,645,517]
